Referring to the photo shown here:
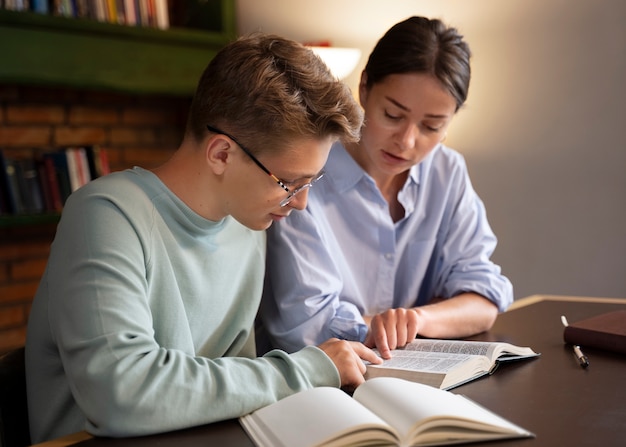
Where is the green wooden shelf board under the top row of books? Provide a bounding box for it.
[0,0,236,96]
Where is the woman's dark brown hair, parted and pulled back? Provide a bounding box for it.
[365,16,471,110]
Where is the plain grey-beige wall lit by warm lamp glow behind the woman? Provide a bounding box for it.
[238,0,626,298]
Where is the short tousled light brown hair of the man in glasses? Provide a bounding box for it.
[187,33,363,153]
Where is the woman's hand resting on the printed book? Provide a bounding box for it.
[365,308,419,359]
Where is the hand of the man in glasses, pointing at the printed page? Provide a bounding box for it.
[318,338,382,390]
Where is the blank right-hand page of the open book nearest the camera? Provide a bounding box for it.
[354,377,531,445]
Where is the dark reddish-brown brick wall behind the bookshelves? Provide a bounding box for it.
[0,85,190,353]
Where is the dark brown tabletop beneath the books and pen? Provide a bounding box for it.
[44,297,626,447]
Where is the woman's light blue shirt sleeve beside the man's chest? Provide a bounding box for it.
[260,208,367,352]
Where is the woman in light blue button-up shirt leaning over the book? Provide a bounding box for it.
[260,17,513,358]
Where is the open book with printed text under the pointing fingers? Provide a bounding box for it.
[365,339,539,390]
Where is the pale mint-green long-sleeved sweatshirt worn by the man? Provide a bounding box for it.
[26,168,340,442]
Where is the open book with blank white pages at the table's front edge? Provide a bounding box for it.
[240,377,534,447]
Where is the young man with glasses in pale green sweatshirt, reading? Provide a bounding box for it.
[26,35,378,442]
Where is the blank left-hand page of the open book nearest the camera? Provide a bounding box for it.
[240,387,397,447]
